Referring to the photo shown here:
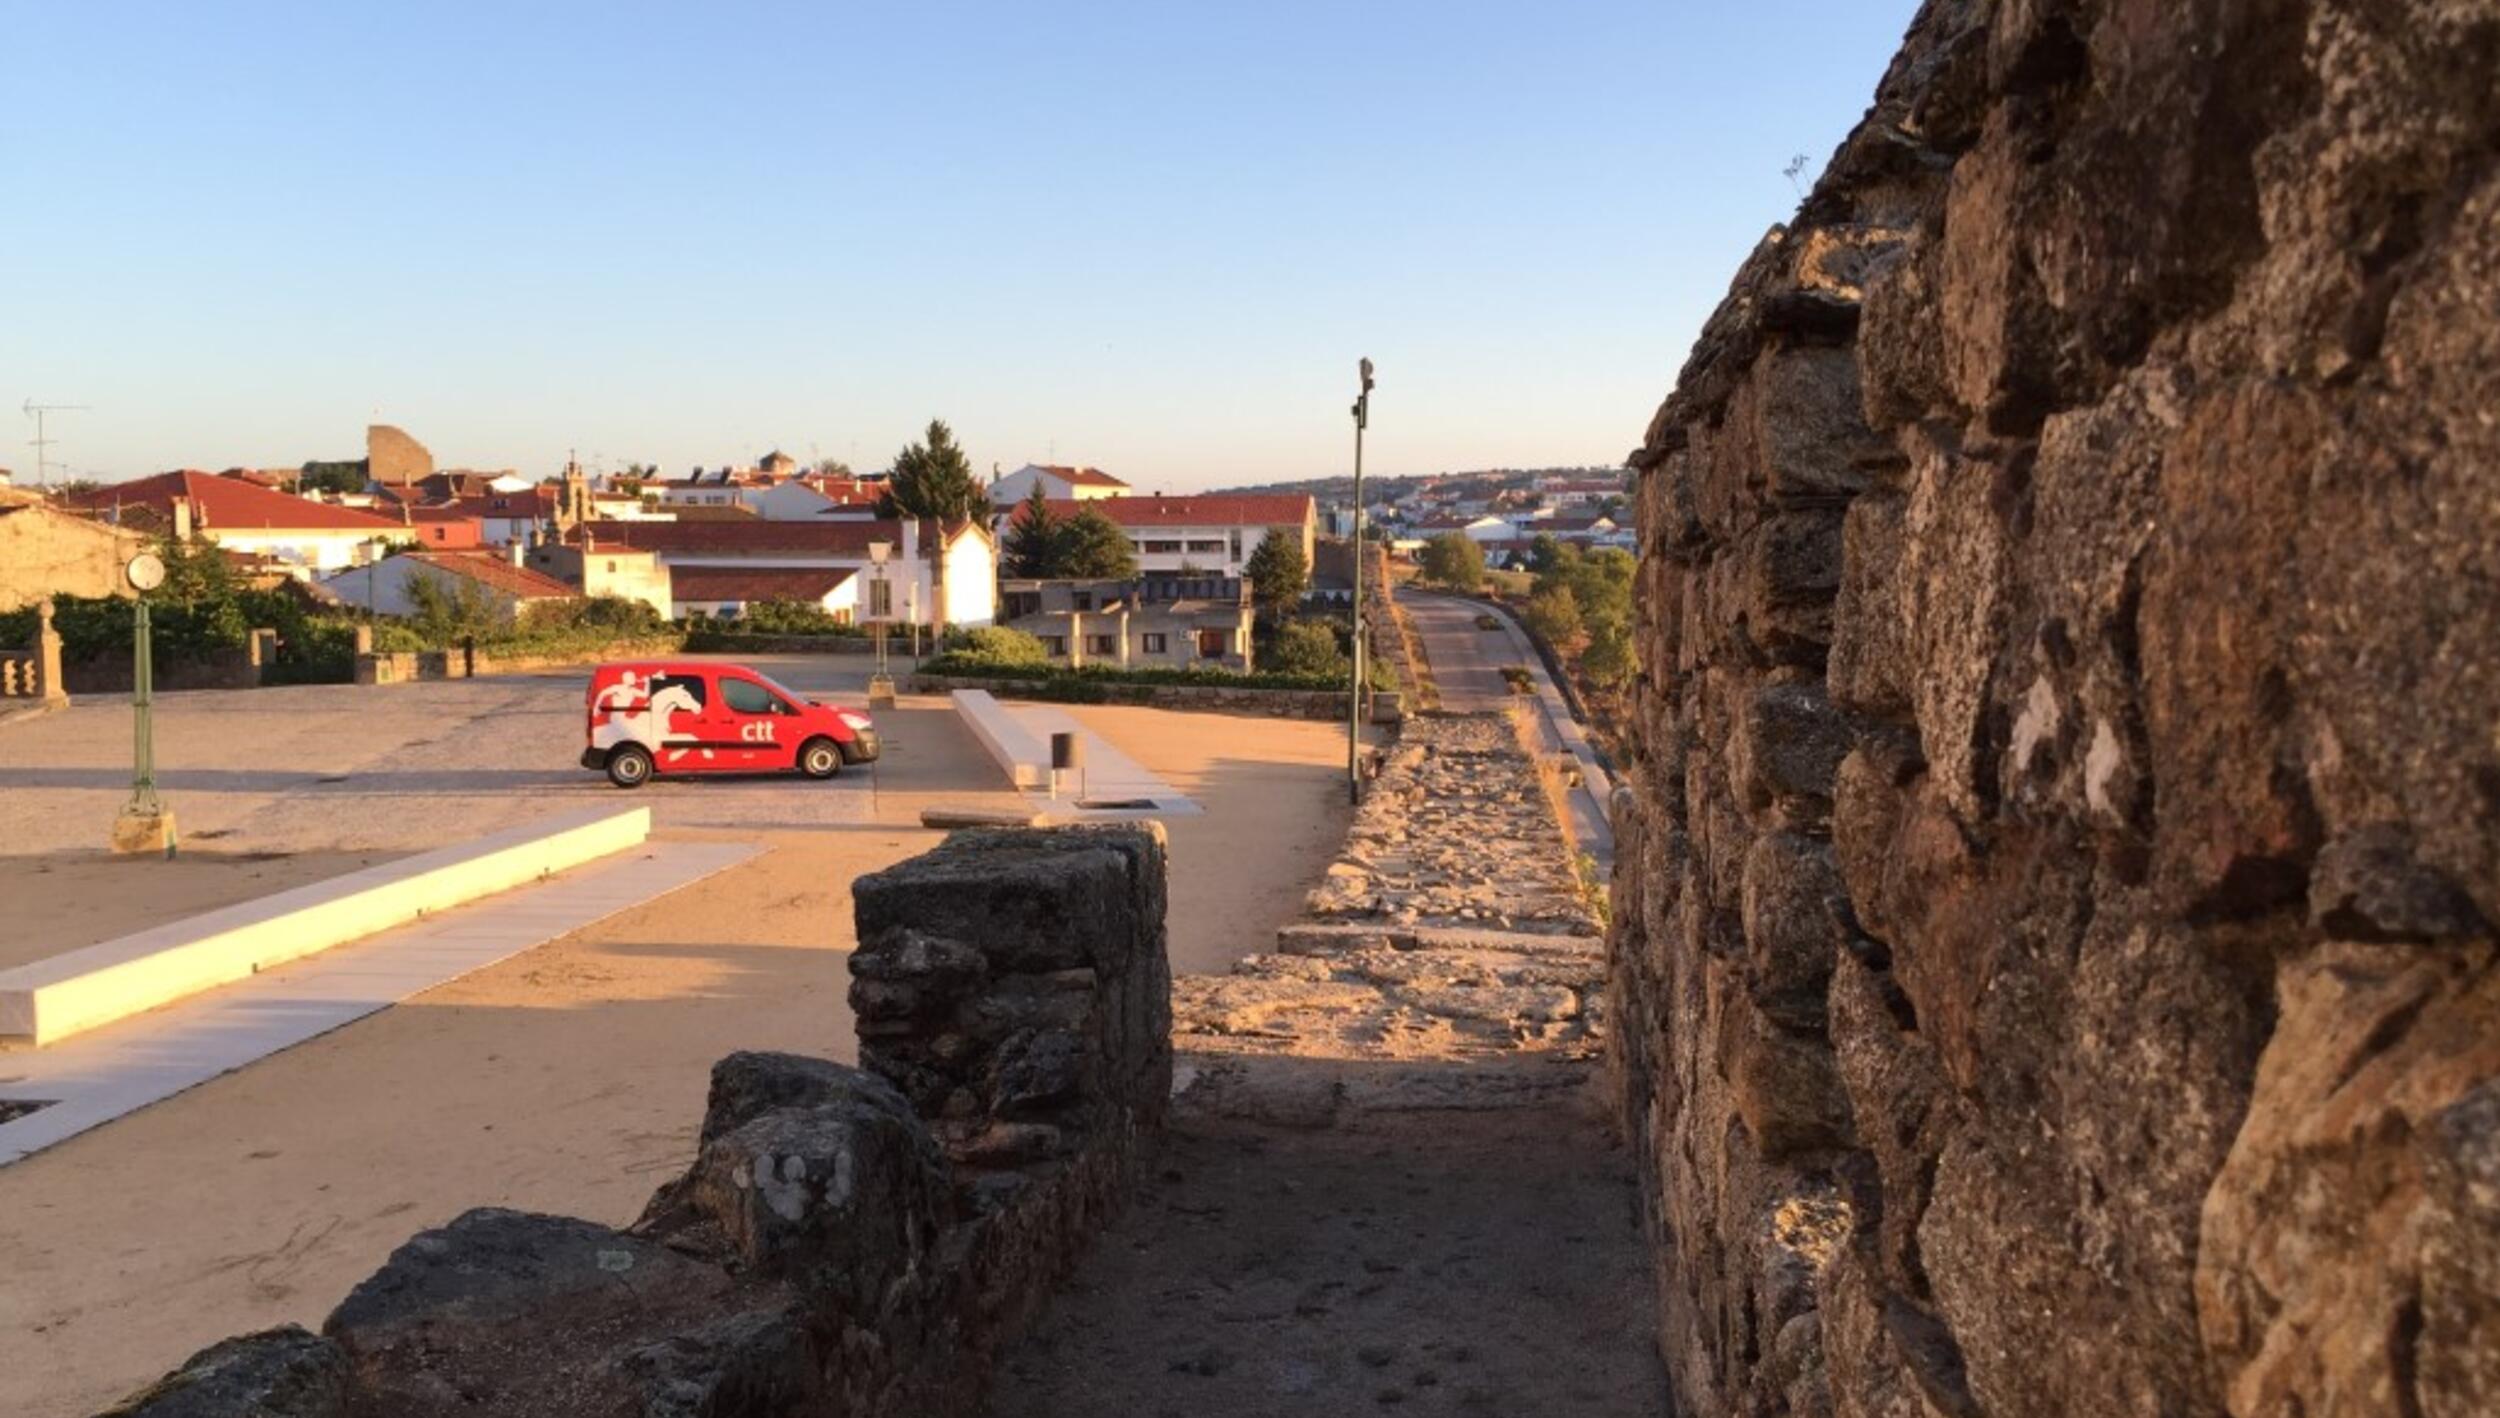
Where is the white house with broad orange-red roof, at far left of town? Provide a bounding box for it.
[60,470,418,573]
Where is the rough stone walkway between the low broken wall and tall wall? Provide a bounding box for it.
[990,713,1665,1418]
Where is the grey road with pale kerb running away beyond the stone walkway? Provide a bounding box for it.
[1398,588,1615,880]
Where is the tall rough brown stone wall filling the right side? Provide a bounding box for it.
[1610,0,2500,1418]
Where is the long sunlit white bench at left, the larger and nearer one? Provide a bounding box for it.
[0,808,650,1048]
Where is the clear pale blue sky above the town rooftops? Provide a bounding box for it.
[0,0,1915,490]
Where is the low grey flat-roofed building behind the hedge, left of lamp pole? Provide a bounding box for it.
[1000,575,1255,670]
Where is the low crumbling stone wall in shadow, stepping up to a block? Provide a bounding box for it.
[115,828,1173,1418]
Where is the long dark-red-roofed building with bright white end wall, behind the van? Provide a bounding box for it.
[583,518,998,625]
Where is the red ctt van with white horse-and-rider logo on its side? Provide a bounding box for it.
[583,663,878,788]
